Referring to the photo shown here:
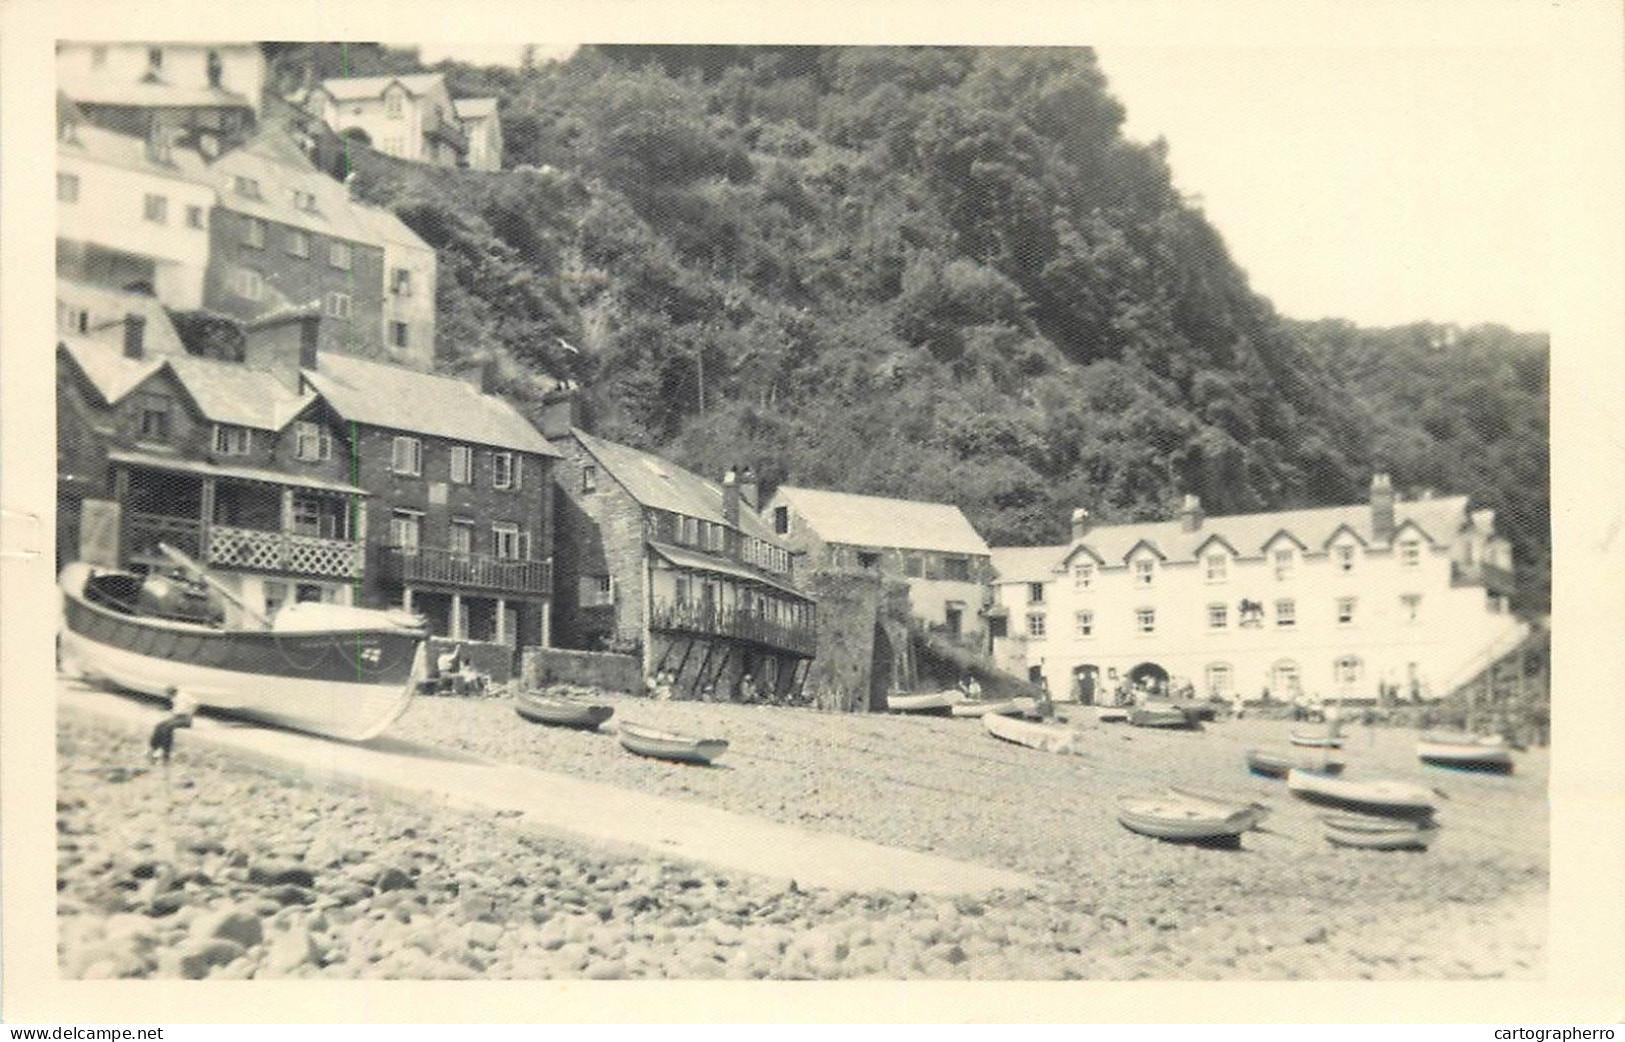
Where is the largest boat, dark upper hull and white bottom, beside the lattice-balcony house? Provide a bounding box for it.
[59,562,426,741]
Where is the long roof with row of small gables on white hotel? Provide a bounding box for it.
[1069,496,1467,564]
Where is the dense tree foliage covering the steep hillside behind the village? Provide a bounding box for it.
[278,46,1549,605]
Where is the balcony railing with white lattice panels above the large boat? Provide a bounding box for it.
[125,510,364,579]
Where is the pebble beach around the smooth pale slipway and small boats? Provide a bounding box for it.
[57,696,1549,980]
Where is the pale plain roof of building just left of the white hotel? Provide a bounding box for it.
[775,484,988,556]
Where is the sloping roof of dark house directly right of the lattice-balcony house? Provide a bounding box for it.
[304,354,559,457]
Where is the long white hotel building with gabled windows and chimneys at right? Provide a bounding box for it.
[990,475,1528,704]
